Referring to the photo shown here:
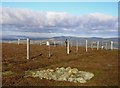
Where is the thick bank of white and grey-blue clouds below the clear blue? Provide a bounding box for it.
[0,8,118,37]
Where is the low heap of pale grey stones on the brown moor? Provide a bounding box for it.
[32,67,94,83]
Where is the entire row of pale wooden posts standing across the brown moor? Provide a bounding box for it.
[15,38,114,59]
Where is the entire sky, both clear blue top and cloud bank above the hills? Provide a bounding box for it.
[0,2,118,38]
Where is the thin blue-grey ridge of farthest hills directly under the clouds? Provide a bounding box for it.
[2,35,118,42]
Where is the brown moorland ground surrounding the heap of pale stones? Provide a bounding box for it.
[2,43,118,86]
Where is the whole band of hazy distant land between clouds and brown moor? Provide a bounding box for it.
[2,36,118,48]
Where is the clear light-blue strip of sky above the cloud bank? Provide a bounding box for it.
[2,2,118,16]
